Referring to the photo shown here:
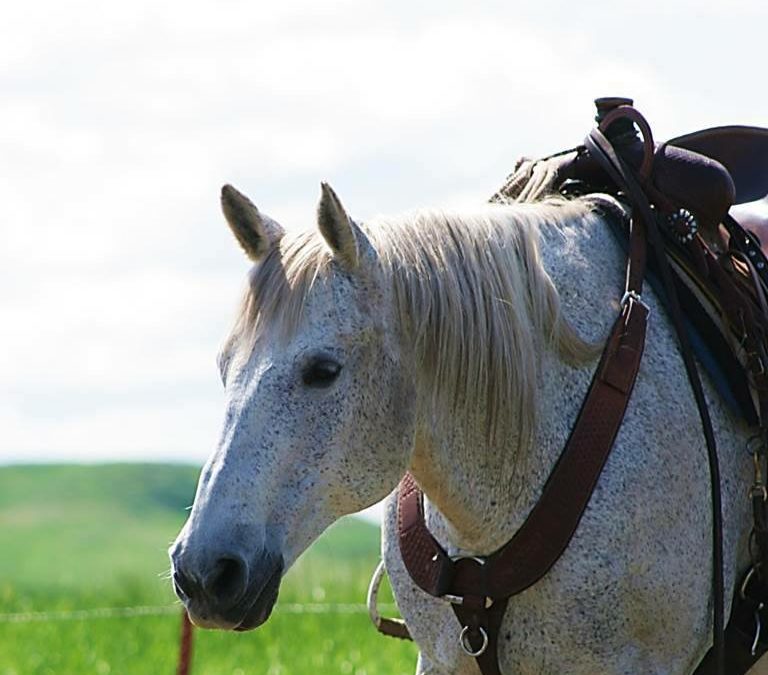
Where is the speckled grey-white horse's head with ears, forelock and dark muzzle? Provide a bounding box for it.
[170,184,415,630]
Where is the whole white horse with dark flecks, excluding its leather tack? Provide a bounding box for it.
[171,185,751,675]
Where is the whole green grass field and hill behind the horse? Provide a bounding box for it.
[0,464,416,675]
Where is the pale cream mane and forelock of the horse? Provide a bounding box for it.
[230,200,595,443]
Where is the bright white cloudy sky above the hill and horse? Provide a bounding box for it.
[0,0,768,464]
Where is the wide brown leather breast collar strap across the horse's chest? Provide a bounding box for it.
[397,264,648,675]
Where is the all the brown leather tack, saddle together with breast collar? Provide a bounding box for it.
[369,98,768,675]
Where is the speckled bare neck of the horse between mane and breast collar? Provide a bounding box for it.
[411,211,624,554]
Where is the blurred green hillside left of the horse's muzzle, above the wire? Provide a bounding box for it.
[0,464,198,612]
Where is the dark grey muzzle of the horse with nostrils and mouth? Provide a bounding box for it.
[171,547,283,631]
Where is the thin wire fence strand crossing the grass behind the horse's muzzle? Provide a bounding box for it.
[0,603,396,623]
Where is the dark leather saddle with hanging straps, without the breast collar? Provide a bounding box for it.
[492,98,768,675]
